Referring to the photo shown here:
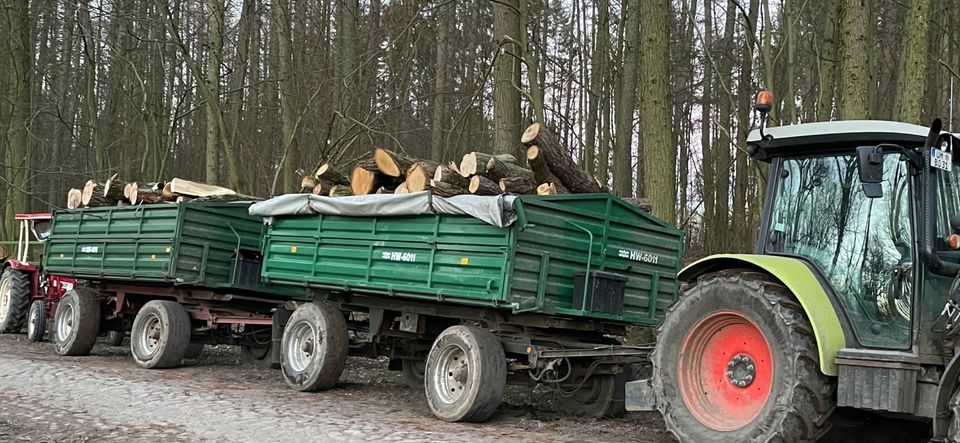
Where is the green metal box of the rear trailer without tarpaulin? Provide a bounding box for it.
[43,202,302,296]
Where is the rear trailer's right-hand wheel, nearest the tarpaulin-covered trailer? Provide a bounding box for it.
[130,300,190,369]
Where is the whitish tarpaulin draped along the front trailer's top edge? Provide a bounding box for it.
[250,191,517,227]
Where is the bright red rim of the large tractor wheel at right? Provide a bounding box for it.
[677,311,773,431]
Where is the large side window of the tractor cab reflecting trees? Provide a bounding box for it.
[768,155,913,349]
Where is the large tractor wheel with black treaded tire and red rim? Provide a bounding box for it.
[653,270,836,442]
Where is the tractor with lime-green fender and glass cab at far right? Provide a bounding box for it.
[627,116,960,442]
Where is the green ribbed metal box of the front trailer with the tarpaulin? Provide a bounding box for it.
[263,194,683,325]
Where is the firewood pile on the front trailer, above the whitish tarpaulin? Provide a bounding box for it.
[298,123,604,197]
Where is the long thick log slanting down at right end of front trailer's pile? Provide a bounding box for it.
[520,122,600,193]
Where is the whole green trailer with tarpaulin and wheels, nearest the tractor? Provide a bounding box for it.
[251,193,683,421]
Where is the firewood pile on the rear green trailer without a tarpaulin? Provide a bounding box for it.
[67,174,258,209]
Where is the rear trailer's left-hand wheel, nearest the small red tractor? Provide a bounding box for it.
[51,289,100,355]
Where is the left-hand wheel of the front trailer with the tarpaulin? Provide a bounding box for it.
[280,302,349,391]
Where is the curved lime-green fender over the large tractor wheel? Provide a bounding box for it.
[678,254,847,376]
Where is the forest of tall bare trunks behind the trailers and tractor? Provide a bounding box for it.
[0,0,960,256]
